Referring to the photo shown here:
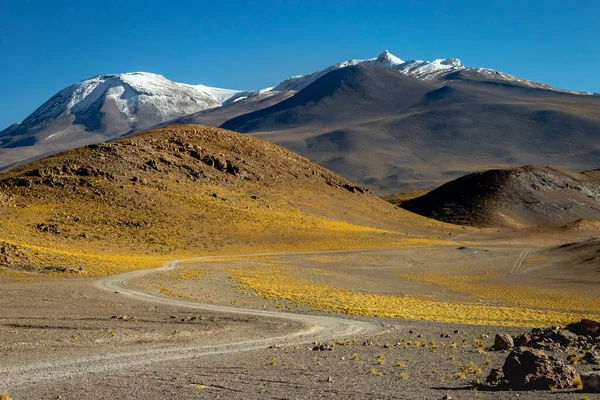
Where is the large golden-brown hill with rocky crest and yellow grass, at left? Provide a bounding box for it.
[0,125,446,274]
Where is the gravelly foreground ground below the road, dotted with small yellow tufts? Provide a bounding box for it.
[5,321,599,399]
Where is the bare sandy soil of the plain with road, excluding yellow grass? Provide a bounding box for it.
[0,236,595,399]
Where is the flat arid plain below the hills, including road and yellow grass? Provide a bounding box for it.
[0,230,600,399]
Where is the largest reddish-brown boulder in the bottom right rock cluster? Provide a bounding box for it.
[485,347,577,390]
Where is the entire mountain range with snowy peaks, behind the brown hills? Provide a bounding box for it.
[0,51,600,194]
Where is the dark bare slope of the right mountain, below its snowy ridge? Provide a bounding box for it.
[222,65,600,194]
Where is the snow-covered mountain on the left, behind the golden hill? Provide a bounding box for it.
[0,72,254,168]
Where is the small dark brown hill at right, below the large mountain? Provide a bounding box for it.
[401,166,600,227]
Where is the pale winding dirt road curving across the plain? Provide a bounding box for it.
[0,254,385,389]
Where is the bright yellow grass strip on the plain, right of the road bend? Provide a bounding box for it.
[229,266,595,327]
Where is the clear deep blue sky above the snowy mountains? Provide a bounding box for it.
[0,0,600,129]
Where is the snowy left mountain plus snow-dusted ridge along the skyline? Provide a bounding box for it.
[0,50,596,169]
